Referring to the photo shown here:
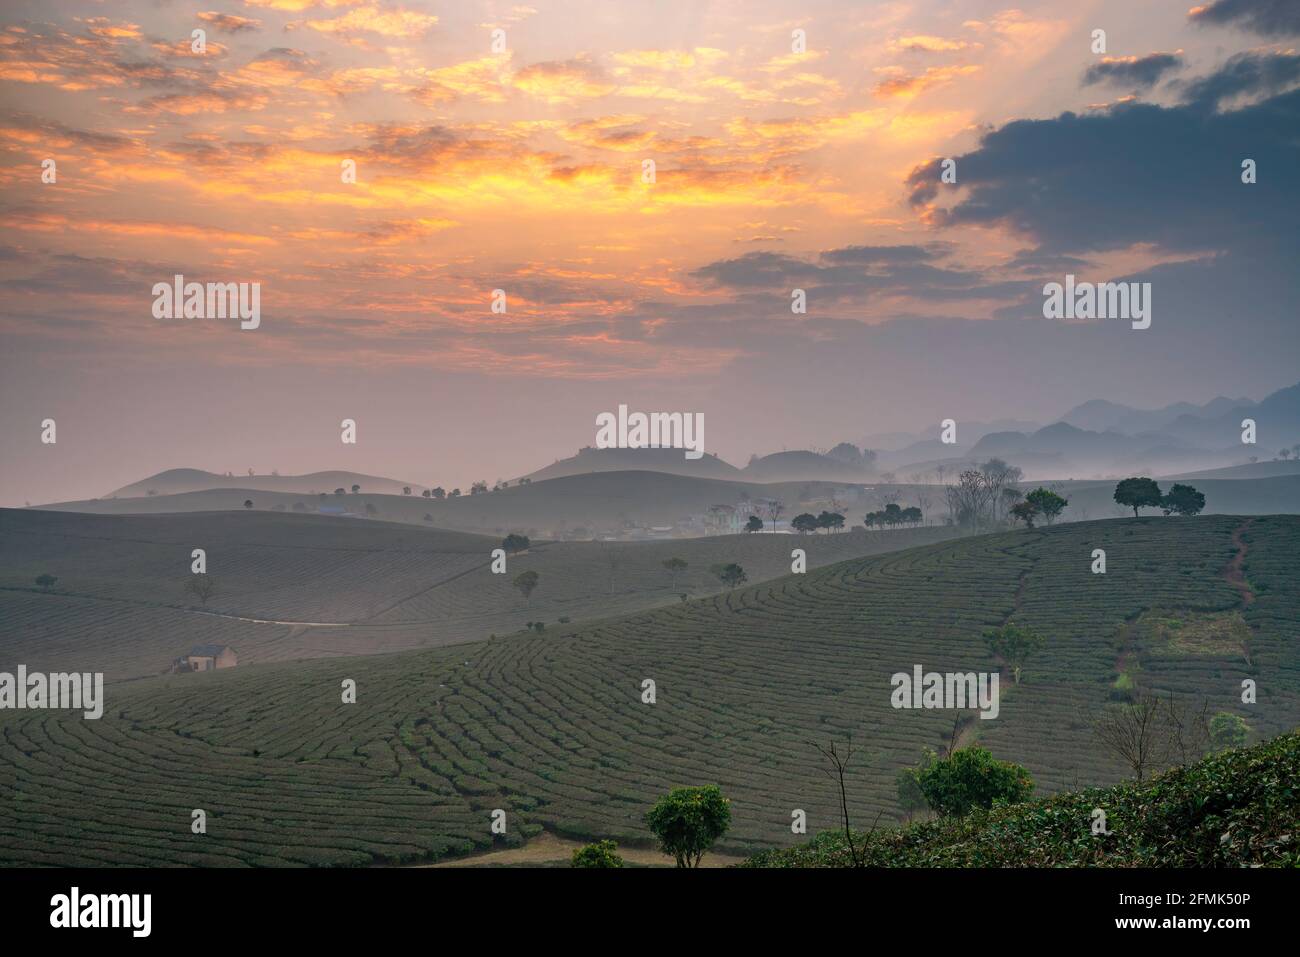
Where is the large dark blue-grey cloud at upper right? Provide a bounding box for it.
[907,68,1300,261]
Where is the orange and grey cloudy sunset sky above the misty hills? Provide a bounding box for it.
[0,0,1300,506]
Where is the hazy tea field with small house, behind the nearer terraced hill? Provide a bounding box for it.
[0,510,953,680]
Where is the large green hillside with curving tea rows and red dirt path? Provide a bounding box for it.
[0,516,1300,865]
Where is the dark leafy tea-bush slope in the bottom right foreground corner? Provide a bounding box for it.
[744,733,1300,867]
